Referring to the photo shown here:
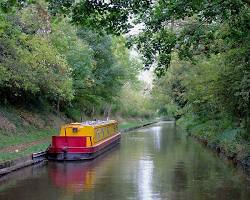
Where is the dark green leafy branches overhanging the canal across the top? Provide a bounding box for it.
[44,0,249,76]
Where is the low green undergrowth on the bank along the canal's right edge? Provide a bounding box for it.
[177,117,250,168]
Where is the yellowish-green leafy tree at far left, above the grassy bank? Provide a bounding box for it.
[0,4,73,102]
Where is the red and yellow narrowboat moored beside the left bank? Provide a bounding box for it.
[47,120,121,161]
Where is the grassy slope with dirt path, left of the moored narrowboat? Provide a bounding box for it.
[0,106,68,162]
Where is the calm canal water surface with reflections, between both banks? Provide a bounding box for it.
[0,122,250,200]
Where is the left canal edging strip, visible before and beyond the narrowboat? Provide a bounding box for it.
[0,121,159,177]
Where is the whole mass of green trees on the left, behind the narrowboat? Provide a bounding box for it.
[0,0,152,120]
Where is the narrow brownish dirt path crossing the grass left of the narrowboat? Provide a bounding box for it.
[0,138,50,153]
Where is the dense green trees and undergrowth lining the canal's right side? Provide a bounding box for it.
[147,0,250,155]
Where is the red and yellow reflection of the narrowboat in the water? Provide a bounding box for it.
[48,146,119,193]
